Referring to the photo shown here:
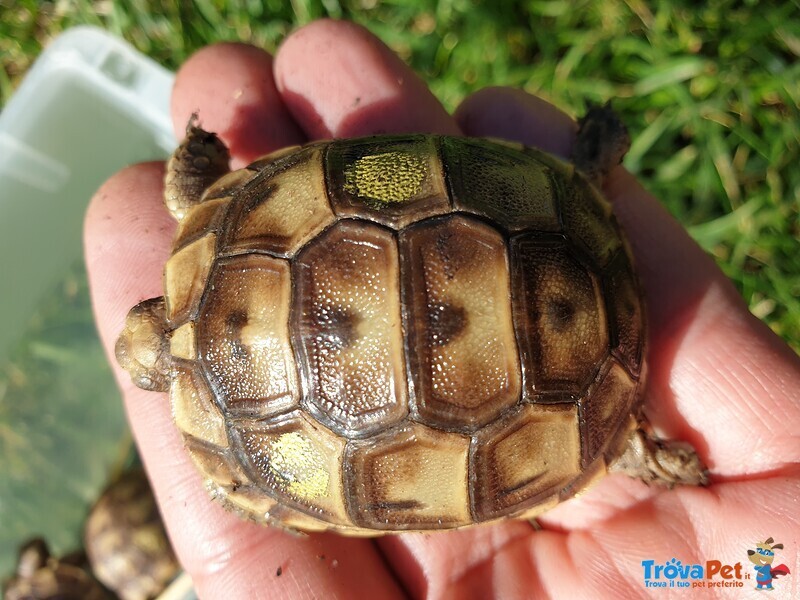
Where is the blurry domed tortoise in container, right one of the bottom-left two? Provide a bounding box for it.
[84,469,178,600]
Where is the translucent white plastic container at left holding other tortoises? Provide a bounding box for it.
[0,27,194,600]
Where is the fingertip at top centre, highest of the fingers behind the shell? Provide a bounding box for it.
[275,21,458,139]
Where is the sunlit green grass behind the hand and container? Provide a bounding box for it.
[0,0,800,350]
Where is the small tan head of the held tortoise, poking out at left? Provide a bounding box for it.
[115,296,172,392]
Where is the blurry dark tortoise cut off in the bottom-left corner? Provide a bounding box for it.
[3,538,112,600]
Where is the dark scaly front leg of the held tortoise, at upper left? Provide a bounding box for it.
[164,114,230,221]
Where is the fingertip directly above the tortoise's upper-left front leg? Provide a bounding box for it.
[172,43,306,168]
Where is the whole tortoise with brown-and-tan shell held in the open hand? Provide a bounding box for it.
[117,107,705,535]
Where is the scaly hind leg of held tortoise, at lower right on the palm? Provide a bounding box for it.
[609,424,708,488]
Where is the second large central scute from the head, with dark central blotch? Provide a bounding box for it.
[293,219,408,435]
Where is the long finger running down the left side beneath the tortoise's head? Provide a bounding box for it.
[85,172,401,600]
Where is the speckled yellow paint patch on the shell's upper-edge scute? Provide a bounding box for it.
[345,151,428,204]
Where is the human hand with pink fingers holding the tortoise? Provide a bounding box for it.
[86,21,800,600]
